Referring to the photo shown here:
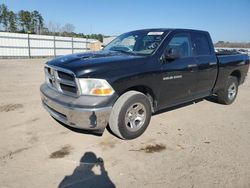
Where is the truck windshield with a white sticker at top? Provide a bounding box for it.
[104,30,166,55]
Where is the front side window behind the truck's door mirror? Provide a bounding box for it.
[167,34,191,58]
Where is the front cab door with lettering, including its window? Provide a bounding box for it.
[158,33,198,108]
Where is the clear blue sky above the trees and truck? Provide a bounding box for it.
[0,0,250,42]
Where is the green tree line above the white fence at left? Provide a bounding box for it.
[0,4,104,42]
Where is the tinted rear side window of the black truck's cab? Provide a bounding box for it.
[194,33,211,55]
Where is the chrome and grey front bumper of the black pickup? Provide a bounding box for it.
[40,84,112,132]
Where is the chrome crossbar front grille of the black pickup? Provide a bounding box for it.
[45,66,77,95]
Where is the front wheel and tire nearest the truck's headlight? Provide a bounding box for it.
[109,91,152,140]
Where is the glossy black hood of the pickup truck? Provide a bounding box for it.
[47,51,148,78]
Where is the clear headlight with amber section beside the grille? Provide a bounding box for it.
[79,78,114,96]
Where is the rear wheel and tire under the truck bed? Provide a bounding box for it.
[218,76,239,105]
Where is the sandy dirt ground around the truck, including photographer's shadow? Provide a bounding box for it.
[0,59,250,188]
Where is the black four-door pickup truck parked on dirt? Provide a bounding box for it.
[40,29,249,139]
